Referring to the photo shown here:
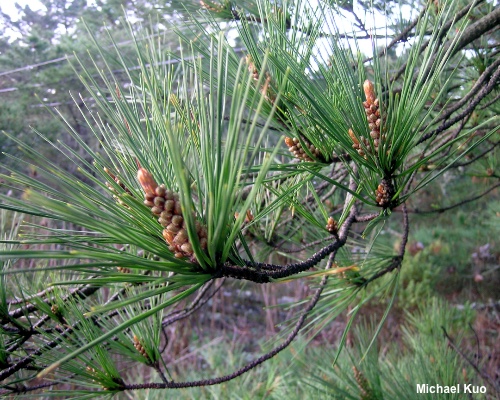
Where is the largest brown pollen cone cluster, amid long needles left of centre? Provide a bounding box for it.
[137,168,207,261]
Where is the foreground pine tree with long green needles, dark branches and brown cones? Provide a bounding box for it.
[0,0,500,398]
